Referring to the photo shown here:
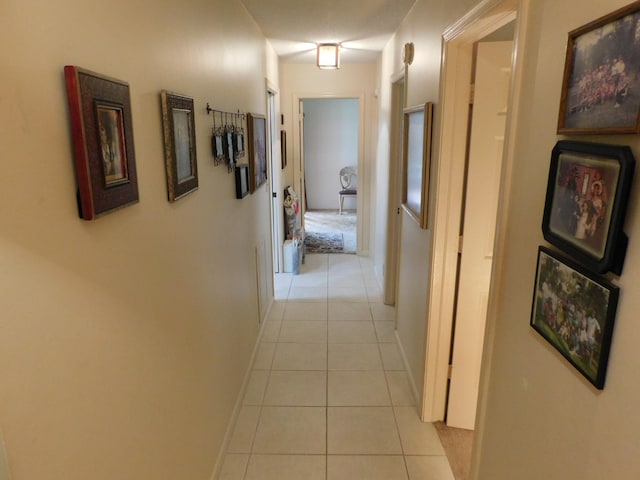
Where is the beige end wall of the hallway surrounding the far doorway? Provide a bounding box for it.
[280,63,378,255]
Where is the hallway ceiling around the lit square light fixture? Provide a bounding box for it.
[241,0,416,64]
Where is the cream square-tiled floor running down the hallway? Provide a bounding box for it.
[219,254,454,480]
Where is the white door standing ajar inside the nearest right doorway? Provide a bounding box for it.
[447,41,513,430]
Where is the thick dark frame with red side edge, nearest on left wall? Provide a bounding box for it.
[64,65,139,220]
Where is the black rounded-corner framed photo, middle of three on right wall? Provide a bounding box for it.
[542,140,635,275]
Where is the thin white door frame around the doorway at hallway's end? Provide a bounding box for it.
[292,93,370,256]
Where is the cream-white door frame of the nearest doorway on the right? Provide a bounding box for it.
[421,0,529,428]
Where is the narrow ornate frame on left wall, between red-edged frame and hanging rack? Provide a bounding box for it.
[160,90,198,202]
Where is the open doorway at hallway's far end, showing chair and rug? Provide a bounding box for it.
[301,98,360,253]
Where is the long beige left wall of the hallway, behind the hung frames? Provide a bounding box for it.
[0,0,278,480]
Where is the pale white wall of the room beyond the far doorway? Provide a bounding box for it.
[303,98,360,210]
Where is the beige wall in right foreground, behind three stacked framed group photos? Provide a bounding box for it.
[476,0,640,480]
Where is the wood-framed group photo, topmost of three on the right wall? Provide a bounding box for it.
[558,2,640,134]
